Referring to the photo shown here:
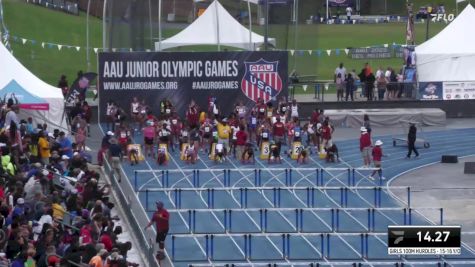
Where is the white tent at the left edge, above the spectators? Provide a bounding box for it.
[0,42,67,131]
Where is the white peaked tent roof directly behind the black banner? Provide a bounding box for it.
[155,0,275,51]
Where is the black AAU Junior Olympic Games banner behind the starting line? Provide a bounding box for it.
[98,51,288,119]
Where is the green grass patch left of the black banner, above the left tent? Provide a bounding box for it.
[3,0,102,85]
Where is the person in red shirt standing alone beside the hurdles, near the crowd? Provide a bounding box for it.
[145,201,170,259]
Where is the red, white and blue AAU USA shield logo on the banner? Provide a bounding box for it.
[241,58,282,102]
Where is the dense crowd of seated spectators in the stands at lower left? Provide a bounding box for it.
[0,99,139,267]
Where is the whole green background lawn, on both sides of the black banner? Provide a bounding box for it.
[3,0,463,89]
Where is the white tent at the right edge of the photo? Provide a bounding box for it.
[416,4,475,81]
